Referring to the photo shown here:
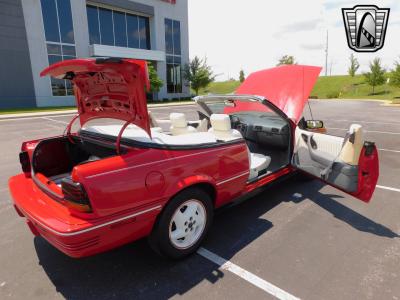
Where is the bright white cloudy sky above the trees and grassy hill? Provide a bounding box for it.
[189,0,400,80]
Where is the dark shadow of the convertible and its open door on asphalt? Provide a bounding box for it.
[34,179,398,299]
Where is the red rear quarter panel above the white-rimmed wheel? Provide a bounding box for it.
[73,141,249,217]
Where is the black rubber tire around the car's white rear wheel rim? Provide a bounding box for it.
[148,188,214,259]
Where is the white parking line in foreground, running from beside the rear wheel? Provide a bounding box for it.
[197,248,299,300]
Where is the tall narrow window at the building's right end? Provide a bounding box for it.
[165,19,182,93]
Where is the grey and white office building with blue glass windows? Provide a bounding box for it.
[0,0,190,108]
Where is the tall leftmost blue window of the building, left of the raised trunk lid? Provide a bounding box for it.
[40,0,76,96]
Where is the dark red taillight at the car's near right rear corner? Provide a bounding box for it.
[61,177,92,212]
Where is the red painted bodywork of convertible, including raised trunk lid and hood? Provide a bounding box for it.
[9,59,378,257]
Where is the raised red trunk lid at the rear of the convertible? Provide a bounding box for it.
[40,58,150,134]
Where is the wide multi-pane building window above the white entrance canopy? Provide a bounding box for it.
[86,5,151,50]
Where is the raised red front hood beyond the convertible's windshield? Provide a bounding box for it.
[236,65,321,123]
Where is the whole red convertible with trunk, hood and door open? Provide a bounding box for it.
[9,58,378,259]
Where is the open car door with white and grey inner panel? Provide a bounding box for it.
[292,124,379,202]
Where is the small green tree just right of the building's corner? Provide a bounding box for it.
[183,56,215,95]
